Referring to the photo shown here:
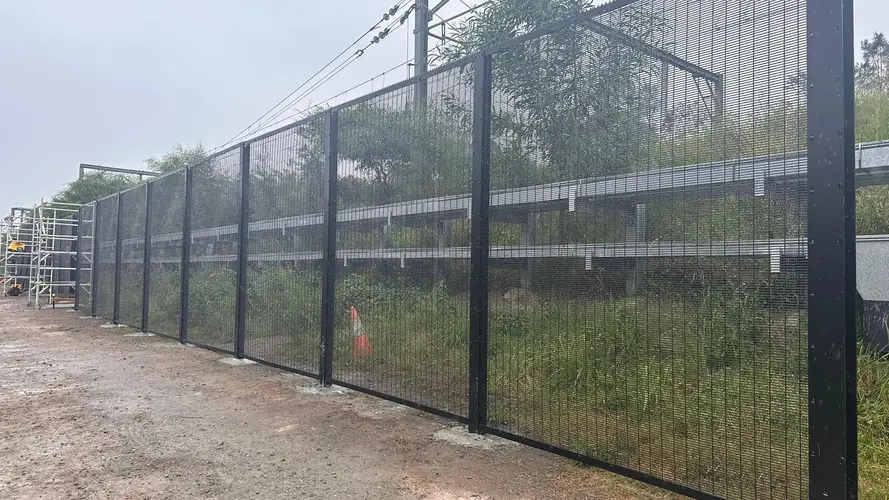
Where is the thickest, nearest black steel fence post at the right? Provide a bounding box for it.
[806,0,858,498]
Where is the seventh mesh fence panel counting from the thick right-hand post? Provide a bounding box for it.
[92,196,117,319]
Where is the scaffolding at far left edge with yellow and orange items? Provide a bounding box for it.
[2,207,34,297]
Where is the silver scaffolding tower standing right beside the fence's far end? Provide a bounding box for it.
[28,200,80,309]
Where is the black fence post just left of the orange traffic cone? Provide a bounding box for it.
[319,111,339,385]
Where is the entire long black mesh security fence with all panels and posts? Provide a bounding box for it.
[77,0,860,498]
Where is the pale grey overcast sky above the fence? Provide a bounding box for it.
[0,0,889,208]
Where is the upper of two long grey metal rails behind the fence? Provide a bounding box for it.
[100,142,889,252]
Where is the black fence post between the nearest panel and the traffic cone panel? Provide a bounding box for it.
[469,53,492,433]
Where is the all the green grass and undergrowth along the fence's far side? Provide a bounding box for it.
[126,260,889,498]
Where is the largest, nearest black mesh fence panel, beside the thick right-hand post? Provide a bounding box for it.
[488,0,808,498]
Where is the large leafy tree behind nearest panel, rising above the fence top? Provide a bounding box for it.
[439,0,666,187]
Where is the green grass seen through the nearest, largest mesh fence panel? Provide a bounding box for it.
[489,297,805,496]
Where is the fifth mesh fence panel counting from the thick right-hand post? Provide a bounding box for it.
[148,171,185,337]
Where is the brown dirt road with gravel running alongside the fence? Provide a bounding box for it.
[0,298,667,500]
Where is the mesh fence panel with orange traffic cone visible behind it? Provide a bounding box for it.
[333,65,473,416]
